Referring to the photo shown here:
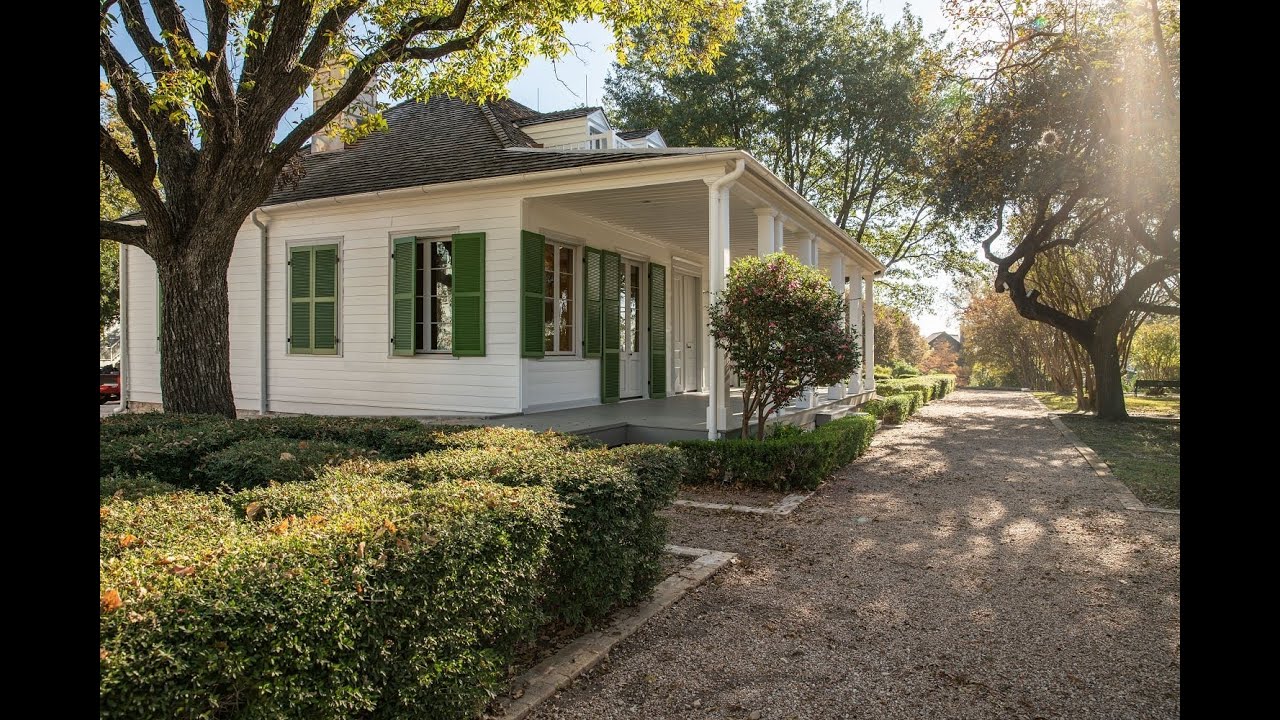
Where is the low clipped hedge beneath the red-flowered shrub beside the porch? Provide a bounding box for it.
[672,414,876,491]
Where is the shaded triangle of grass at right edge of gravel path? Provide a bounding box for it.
[1061,415,1181,510]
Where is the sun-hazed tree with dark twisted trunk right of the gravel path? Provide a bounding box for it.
[929,0,1181,420]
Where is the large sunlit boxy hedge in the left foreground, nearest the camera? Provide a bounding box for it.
[99,477,558,720]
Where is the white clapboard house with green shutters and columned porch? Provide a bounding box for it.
[122,90,883,437]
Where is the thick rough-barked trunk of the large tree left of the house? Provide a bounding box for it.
[156,233,238,418]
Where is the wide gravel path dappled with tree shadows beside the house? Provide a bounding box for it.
[532,391,1180,720]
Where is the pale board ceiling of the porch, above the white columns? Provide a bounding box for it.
[534,181,832,269]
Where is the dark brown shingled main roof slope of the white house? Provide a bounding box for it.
[262,97,680,206]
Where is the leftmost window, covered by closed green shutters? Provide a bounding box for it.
[288,245,339,355]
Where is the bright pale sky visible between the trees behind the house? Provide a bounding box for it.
[507,0,959,334]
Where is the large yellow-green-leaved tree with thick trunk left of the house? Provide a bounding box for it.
[99,0,740,416]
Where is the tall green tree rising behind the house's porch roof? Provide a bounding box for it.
[605,0,978,309]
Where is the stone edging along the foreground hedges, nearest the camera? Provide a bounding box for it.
[485,544,737,720]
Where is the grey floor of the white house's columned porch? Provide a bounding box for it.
[477,388,876,446]
